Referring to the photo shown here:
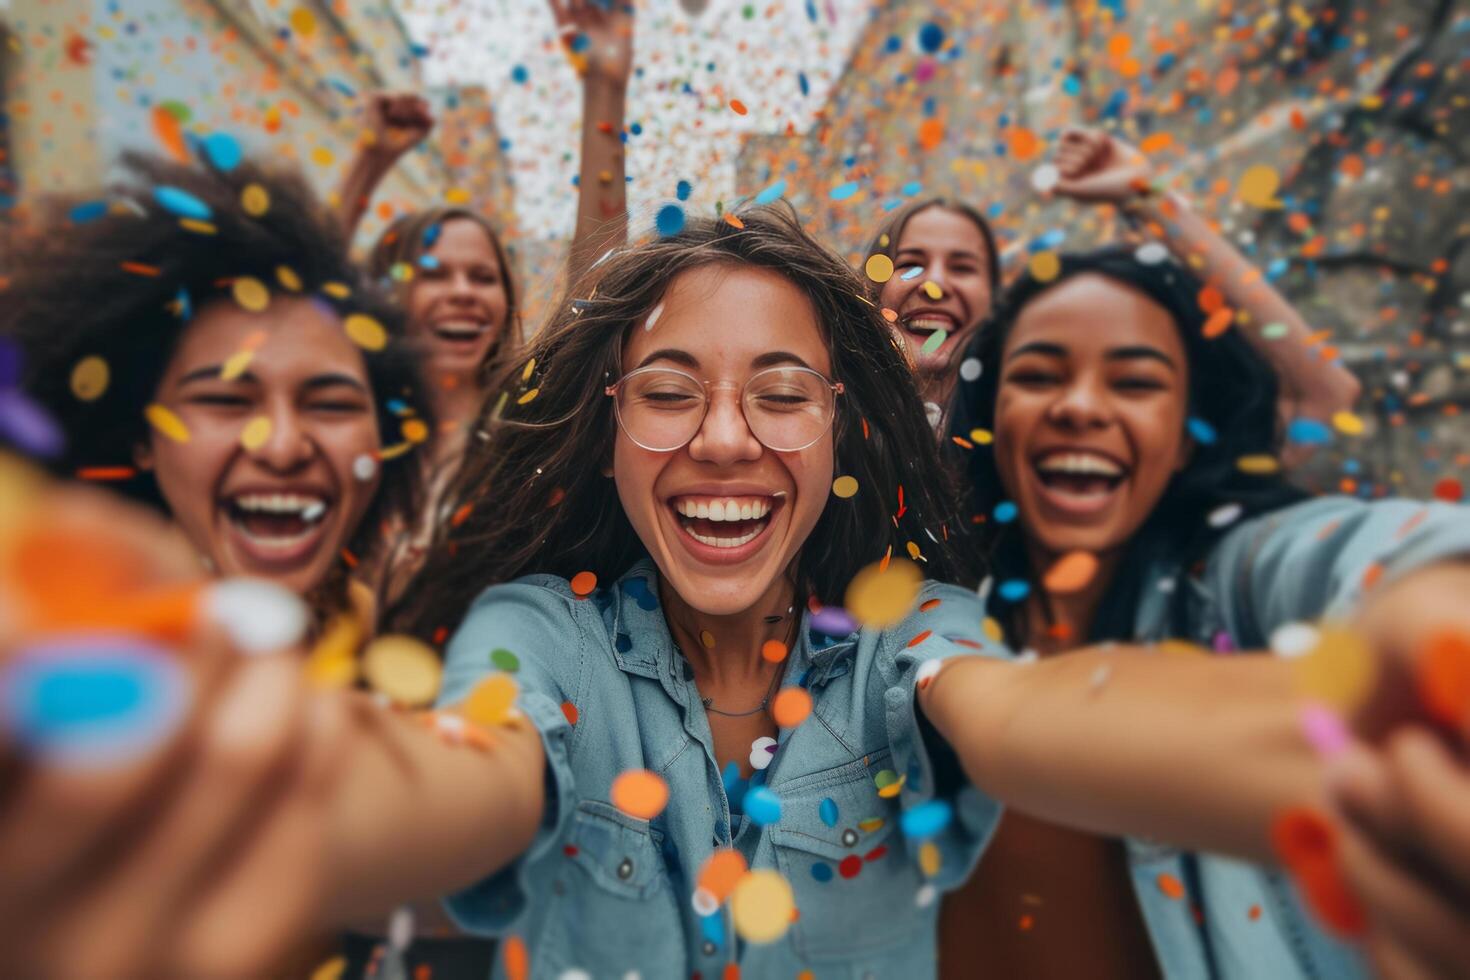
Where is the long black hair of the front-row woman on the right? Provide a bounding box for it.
[948,247,1304,642]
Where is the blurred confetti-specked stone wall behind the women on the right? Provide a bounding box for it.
[739,0,1470,497]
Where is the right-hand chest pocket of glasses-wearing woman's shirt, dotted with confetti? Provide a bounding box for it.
[770,749,926,962]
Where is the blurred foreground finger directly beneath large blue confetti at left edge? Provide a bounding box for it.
[0,627,238,902]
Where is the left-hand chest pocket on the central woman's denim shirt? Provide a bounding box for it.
[532,799,685,977]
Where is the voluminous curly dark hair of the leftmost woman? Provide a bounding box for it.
[0,153,434,617]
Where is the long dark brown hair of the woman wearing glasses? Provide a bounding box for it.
[400,206,961,638]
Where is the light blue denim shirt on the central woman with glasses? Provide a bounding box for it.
[441,561,1008,980]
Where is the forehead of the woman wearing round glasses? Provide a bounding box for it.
[623,263,832,378]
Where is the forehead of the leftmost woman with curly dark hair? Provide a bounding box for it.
[169,297,368,381]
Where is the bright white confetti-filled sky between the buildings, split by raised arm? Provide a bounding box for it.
[398,0,869,237]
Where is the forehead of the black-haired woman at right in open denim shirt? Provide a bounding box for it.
[1005,272,1185,364]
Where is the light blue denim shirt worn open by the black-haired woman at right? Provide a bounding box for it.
[1105,497,1470,980]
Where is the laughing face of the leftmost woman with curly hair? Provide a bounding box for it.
[138,298,381,594]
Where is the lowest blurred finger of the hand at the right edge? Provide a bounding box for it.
[1338,826,1470,965]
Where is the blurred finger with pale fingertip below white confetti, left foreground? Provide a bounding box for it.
[41,655,304,976]
